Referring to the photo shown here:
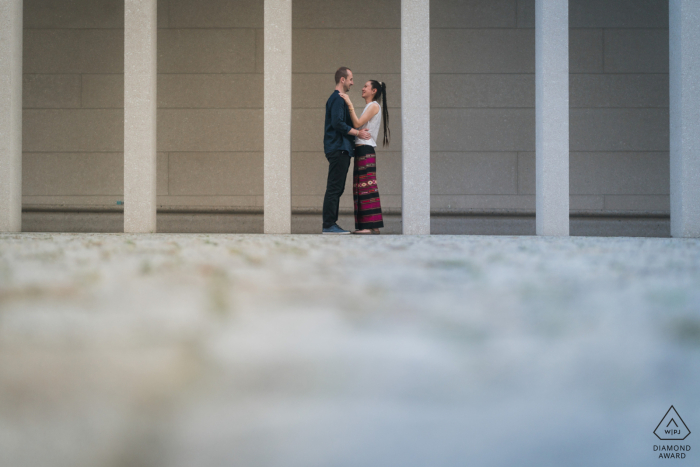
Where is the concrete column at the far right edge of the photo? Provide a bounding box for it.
[669,0,700,238]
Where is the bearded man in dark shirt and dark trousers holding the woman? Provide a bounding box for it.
[323,66,371,235]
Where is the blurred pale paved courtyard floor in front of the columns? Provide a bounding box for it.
[0,234,700,467]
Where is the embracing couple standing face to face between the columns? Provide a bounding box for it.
[323,67,390,235]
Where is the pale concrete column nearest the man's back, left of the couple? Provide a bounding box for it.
[264,0,292,234]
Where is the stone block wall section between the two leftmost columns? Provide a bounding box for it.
[22,0,124,206]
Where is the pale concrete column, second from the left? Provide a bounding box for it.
[124,0,158,232]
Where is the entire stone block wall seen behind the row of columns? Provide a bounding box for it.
[23,0,669,219]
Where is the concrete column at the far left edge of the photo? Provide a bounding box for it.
[0,0,23,232]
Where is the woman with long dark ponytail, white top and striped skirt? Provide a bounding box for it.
[340,80,391,235]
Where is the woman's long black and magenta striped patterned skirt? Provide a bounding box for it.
[352,145,384,230]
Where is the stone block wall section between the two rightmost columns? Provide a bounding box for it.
[568,0,670,213]
